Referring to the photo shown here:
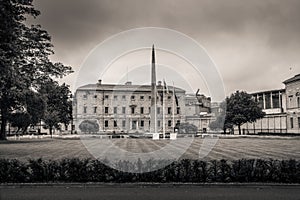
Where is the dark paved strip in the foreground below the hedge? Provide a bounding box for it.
[0,184,300,200]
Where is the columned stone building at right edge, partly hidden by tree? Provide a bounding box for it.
[238,74,300,134]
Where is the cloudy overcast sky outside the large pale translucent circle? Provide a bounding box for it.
[34,0,300,100]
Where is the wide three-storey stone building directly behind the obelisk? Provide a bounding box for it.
[73,81,185,133]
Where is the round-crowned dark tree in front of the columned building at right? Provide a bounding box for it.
[211,91,265,135]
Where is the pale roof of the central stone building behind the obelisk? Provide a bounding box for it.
[76,84,185,93]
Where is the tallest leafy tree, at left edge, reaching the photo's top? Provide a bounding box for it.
[0,0,71,139]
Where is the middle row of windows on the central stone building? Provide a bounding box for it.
[83,106,180,115]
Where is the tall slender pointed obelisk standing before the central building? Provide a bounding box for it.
[150,45,157,133]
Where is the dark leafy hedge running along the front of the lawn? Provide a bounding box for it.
[0,158,300,183]
